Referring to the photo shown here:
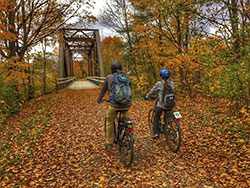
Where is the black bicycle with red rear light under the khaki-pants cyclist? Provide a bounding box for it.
[105,110,134,167]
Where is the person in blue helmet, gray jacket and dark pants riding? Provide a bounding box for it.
[145,69,174,138]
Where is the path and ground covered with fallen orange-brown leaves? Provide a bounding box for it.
[0,90,250,188]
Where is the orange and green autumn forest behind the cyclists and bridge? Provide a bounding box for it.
[0,0,250,123]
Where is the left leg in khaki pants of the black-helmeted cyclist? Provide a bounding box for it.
[105,105,117,145]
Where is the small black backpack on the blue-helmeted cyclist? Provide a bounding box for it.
[162,80,176,110]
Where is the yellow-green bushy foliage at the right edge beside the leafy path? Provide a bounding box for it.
[204,43,250,112]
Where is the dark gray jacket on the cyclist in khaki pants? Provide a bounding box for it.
[97,74,131,109]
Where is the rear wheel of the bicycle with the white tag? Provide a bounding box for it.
[165,121,181,153]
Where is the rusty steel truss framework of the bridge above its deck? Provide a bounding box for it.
[58,28,104,78]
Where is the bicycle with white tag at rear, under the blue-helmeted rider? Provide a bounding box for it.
[148,97,182,153]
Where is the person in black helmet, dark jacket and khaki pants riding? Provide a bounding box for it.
[97,61,131,149]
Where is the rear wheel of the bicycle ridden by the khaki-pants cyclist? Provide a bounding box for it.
[119,129,134,167]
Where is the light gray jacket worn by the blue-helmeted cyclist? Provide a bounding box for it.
[146,80,174,108]
